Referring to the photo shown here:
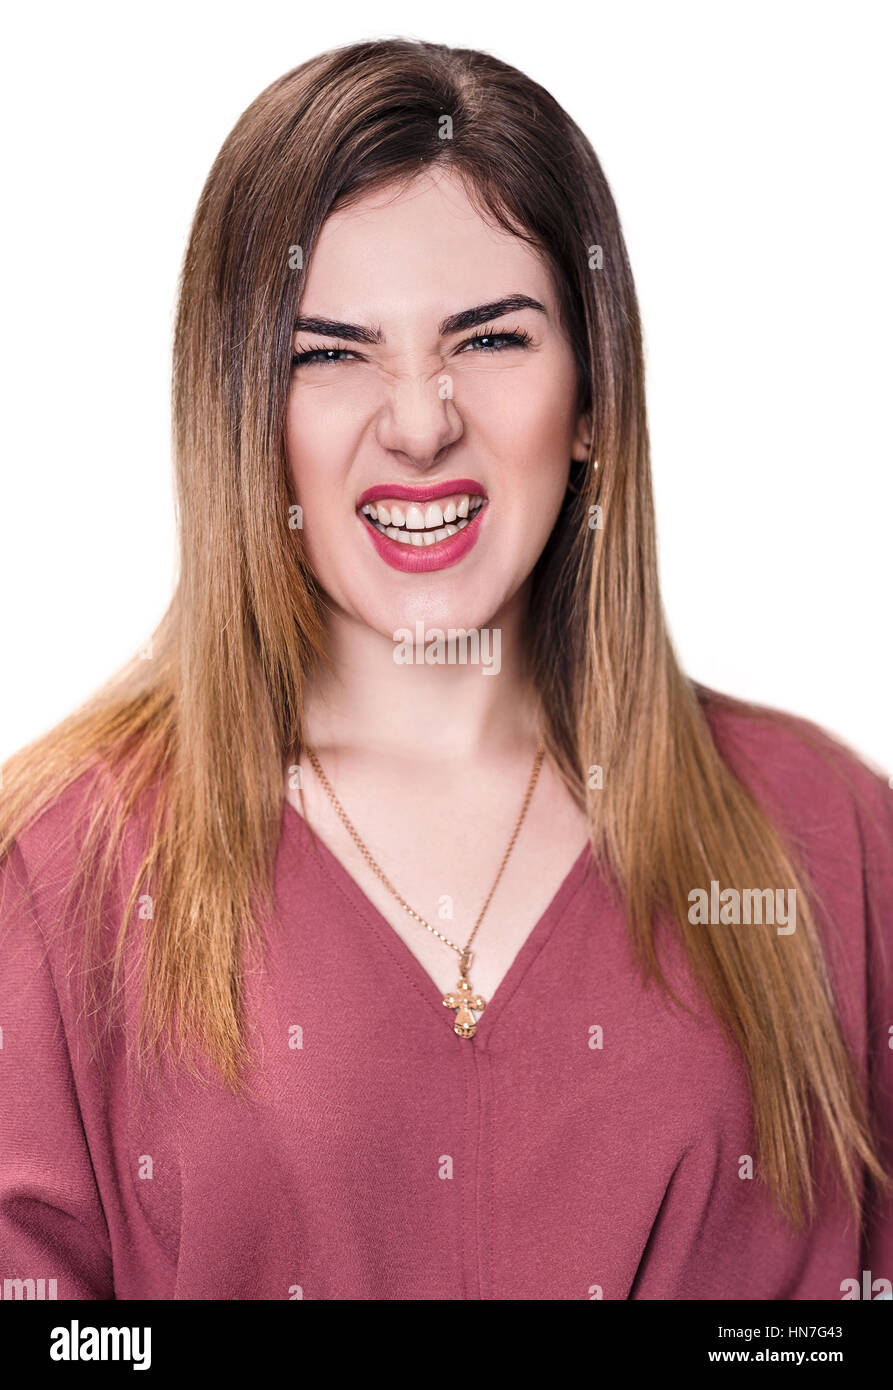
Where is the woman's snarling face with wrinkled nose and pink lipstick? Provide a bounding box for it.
[287,171,588,637]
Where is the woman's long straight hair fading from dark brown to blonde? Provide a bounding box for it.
[0,39,885,1223]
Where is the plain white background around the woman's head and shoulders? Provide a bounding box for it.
[0,0,893,770]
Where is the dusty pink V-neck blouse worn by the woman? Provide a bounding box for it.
[0,712,893,1300]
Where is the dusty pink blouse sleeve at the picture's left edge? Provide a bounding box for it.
[0,844,114,1300]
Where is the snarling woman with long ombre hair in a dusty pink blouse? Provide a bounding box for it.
[0,40,893,1300]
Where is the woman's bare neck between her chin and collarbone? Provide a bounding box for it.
[305,583,538,763]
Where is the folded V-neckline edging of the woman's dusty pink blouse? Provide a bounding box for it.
[282,796,590,1048]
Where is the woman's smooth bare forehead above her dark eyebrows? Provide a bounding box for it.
[300,168,552,324]
